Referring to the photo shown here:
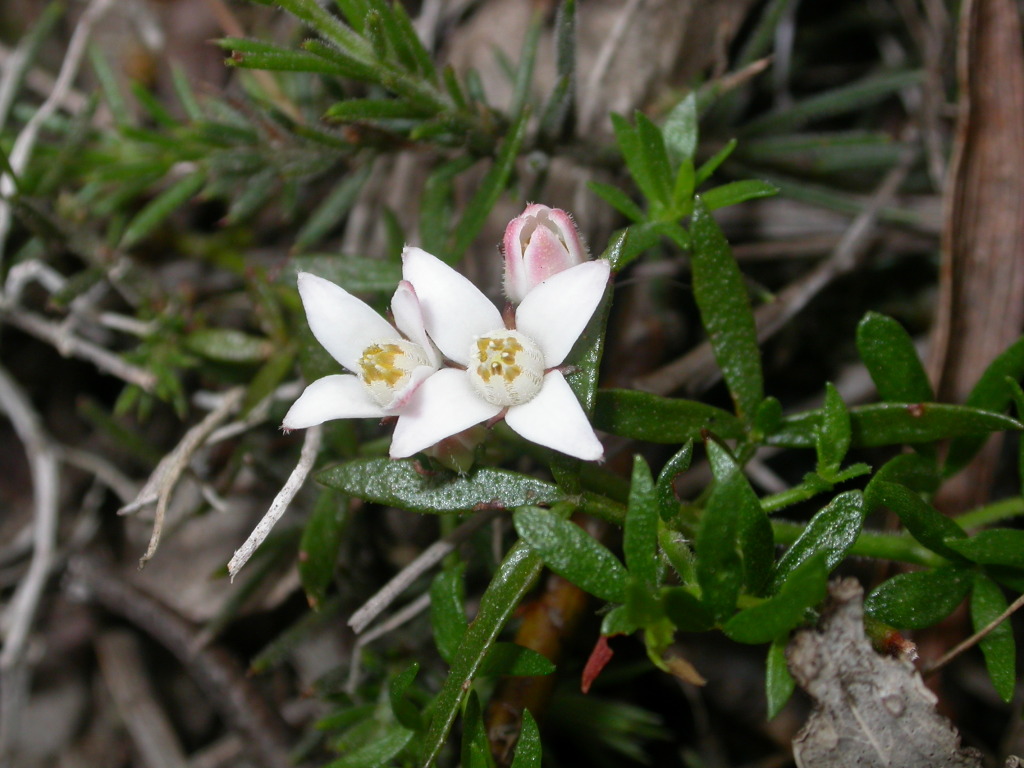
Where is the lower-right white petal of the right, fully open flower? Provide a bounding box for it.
[505,371,604,462]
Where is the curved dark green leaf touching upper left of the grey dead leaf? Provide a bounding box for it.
[722,552,828,644]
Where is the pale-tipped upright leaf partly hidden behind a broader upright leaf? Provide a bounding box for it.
[698,440,775,595]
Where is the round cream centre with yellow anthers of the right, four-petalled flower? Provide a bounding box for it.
[467,329,544,406]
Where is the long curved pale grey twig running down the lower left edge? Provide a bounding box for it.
[0,368,60,762]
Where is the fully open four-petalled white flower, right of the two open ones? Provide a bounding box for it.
[391,248,610,461]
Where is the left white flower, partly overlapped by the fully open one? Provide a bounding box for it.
[282,272,441,429]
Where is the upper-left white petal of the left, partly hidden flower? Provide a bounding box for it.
[299,272,401,372]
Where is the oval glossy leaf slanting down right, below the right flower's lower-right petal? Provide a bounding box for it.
[512,507,629,603]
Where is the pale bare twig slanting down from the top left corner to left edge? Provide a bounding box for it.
[0,0,114,264]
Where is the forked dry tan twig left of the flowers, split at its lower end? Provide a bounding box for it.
[119,387,246,567]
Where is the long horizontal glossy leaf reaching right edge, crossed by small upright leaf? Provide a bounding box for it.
[766,402,1021,447]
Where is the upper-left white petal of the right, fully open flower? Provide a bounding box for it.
[401,247,505,366]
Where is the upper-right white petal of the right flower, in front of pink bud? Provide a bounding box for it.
[515,259,611,368]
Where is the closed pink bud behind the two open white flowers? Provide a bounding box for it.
[502,203,587,303]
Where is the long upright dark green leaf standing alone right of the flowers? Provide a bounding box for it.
[690,197,764,422]
